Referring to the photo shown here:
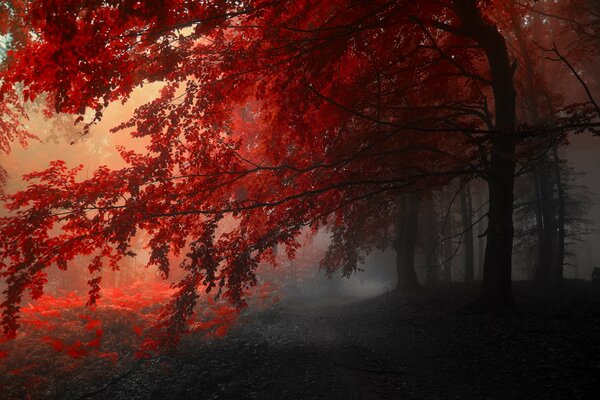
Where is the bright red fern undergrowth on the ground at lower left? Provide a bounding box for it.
[0,282,274,397]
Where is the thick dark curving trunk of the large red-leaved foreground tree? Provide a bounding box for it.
[453,0,515,311]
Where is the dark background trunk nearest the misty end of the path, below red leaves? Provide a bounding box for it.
[394,193,420,290]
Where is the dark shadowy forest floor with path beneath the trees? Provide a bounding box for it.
[57,282,600,400]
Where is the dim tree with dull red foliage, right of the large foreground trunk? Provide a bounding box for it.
[503,1,597,287]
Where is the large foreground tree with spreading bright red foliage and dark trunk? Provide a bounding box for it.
[0,0,596,333]
